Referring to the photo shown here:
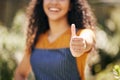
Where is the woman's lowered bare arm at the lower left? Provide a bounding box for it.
[14,54,31,80]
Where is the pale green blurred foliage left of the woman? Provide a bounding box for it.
[0,11,25,80]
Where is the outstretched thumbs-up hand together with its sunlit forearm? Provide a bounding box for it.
[70,24,95,57]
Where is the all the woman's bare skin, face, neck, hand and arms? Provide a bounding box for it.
[14,0,94,80]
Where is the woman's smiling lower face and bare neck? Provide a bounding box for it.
[43,0,70,42]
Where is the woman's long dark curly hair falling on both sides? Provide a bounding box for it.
[26,0,96,53]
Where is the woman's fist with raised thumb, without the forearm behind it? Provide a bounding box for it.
[70,24,86,57]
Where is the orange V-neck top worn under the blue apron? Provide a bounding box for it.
[35,28,88,80]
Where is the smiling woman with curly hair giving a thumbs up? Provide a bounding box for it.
[15,0,95,80]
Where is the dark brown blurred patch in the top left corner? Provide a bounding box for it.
[0,0,29,27]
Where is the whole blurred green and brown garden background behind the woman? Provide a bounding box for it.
[0,0,120,80]
